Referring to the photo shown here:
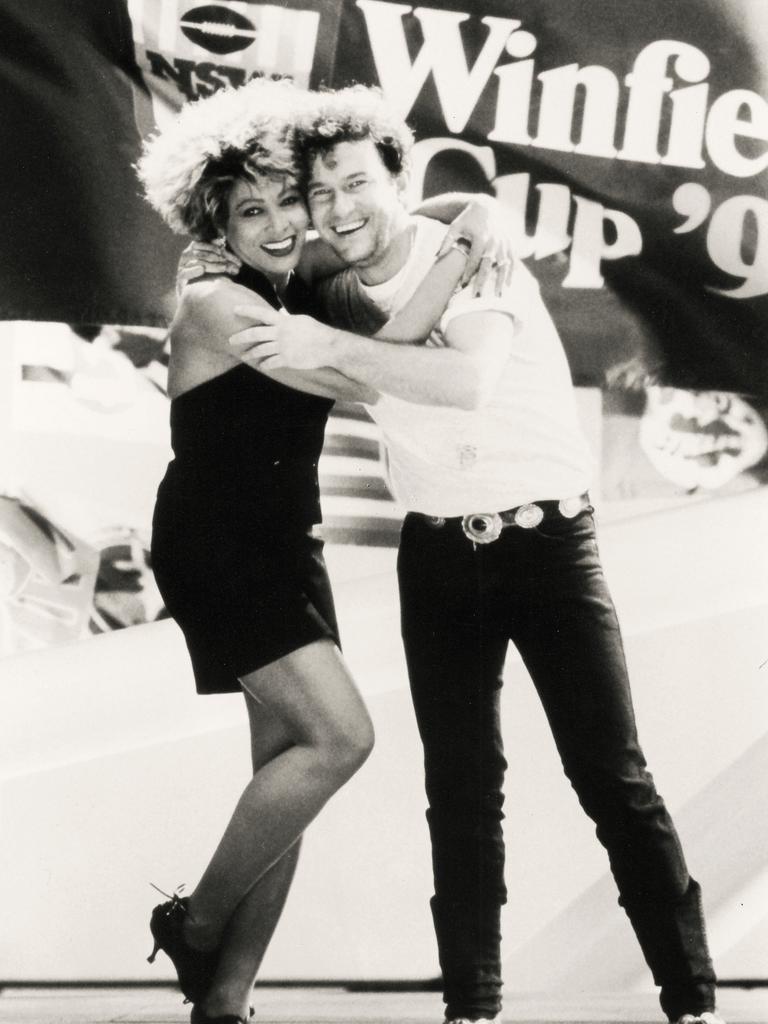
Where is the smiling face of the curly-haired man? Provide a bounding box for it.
[307,138,410,285]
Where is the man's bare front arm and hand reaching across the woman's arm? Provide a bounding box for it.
[232,309,514,410]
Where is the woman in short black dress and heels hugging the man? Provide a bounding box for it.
[139,81,493,1024]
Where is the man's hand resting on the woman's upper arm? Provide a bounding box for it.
[229,305,334,370]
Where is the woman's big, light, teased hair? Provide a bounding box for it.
[136,79,308,242]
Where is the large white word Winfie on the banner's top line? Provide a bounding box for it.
[356,0,768,177]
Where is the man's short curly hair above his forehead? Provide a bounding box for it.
[296,85,414,186]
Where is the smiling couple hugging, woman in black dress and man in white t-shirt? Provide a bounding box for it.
[139,75,719,1024]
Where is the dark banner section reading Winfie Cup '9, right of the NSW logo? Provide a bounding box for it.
[325,0,768,393]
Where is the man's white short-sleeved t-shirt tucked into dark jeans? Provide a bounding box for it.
[360,217,592,516]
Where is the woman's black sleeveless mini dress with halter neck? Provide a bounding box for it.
[152,267,339,693]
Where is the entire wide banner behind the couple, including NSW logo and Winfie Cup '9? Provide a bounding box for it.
[0,0,768,395]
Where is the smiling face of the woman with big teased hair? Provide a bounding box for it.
[226,175,309,283]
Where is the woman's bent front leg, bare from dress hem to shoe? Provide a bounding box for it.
[186,640,373,947]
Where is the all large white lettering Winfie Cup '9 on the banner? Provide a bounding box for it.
[356,0,768,299]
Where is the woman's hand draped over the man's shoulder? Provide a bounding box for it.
[436,193,513,295]
